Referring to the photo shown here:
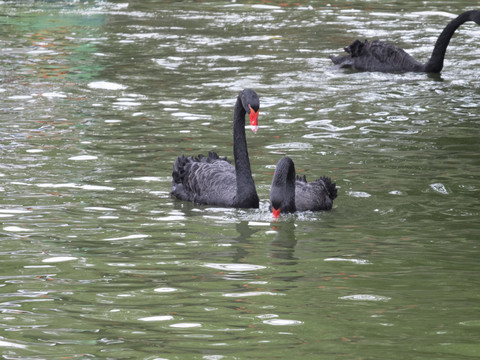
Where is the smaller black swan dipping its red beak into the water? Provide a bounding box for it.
[270,156,337,218]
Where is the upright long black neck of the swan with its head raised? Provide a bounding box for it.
[233,96,259,208]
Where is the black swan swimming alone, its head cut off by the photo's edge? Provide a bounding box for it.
[330,10,480,73]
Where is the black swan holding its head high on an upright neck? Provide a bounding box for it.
[170,89,260,208]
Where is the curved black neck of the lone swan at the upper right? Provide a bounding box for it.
[425,10,477,73]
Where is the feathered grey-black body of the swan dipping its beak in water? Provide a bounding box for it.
[295,176,337,211]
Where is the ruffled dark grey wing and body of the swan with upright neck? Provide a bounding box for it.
[171,152,236,206]
